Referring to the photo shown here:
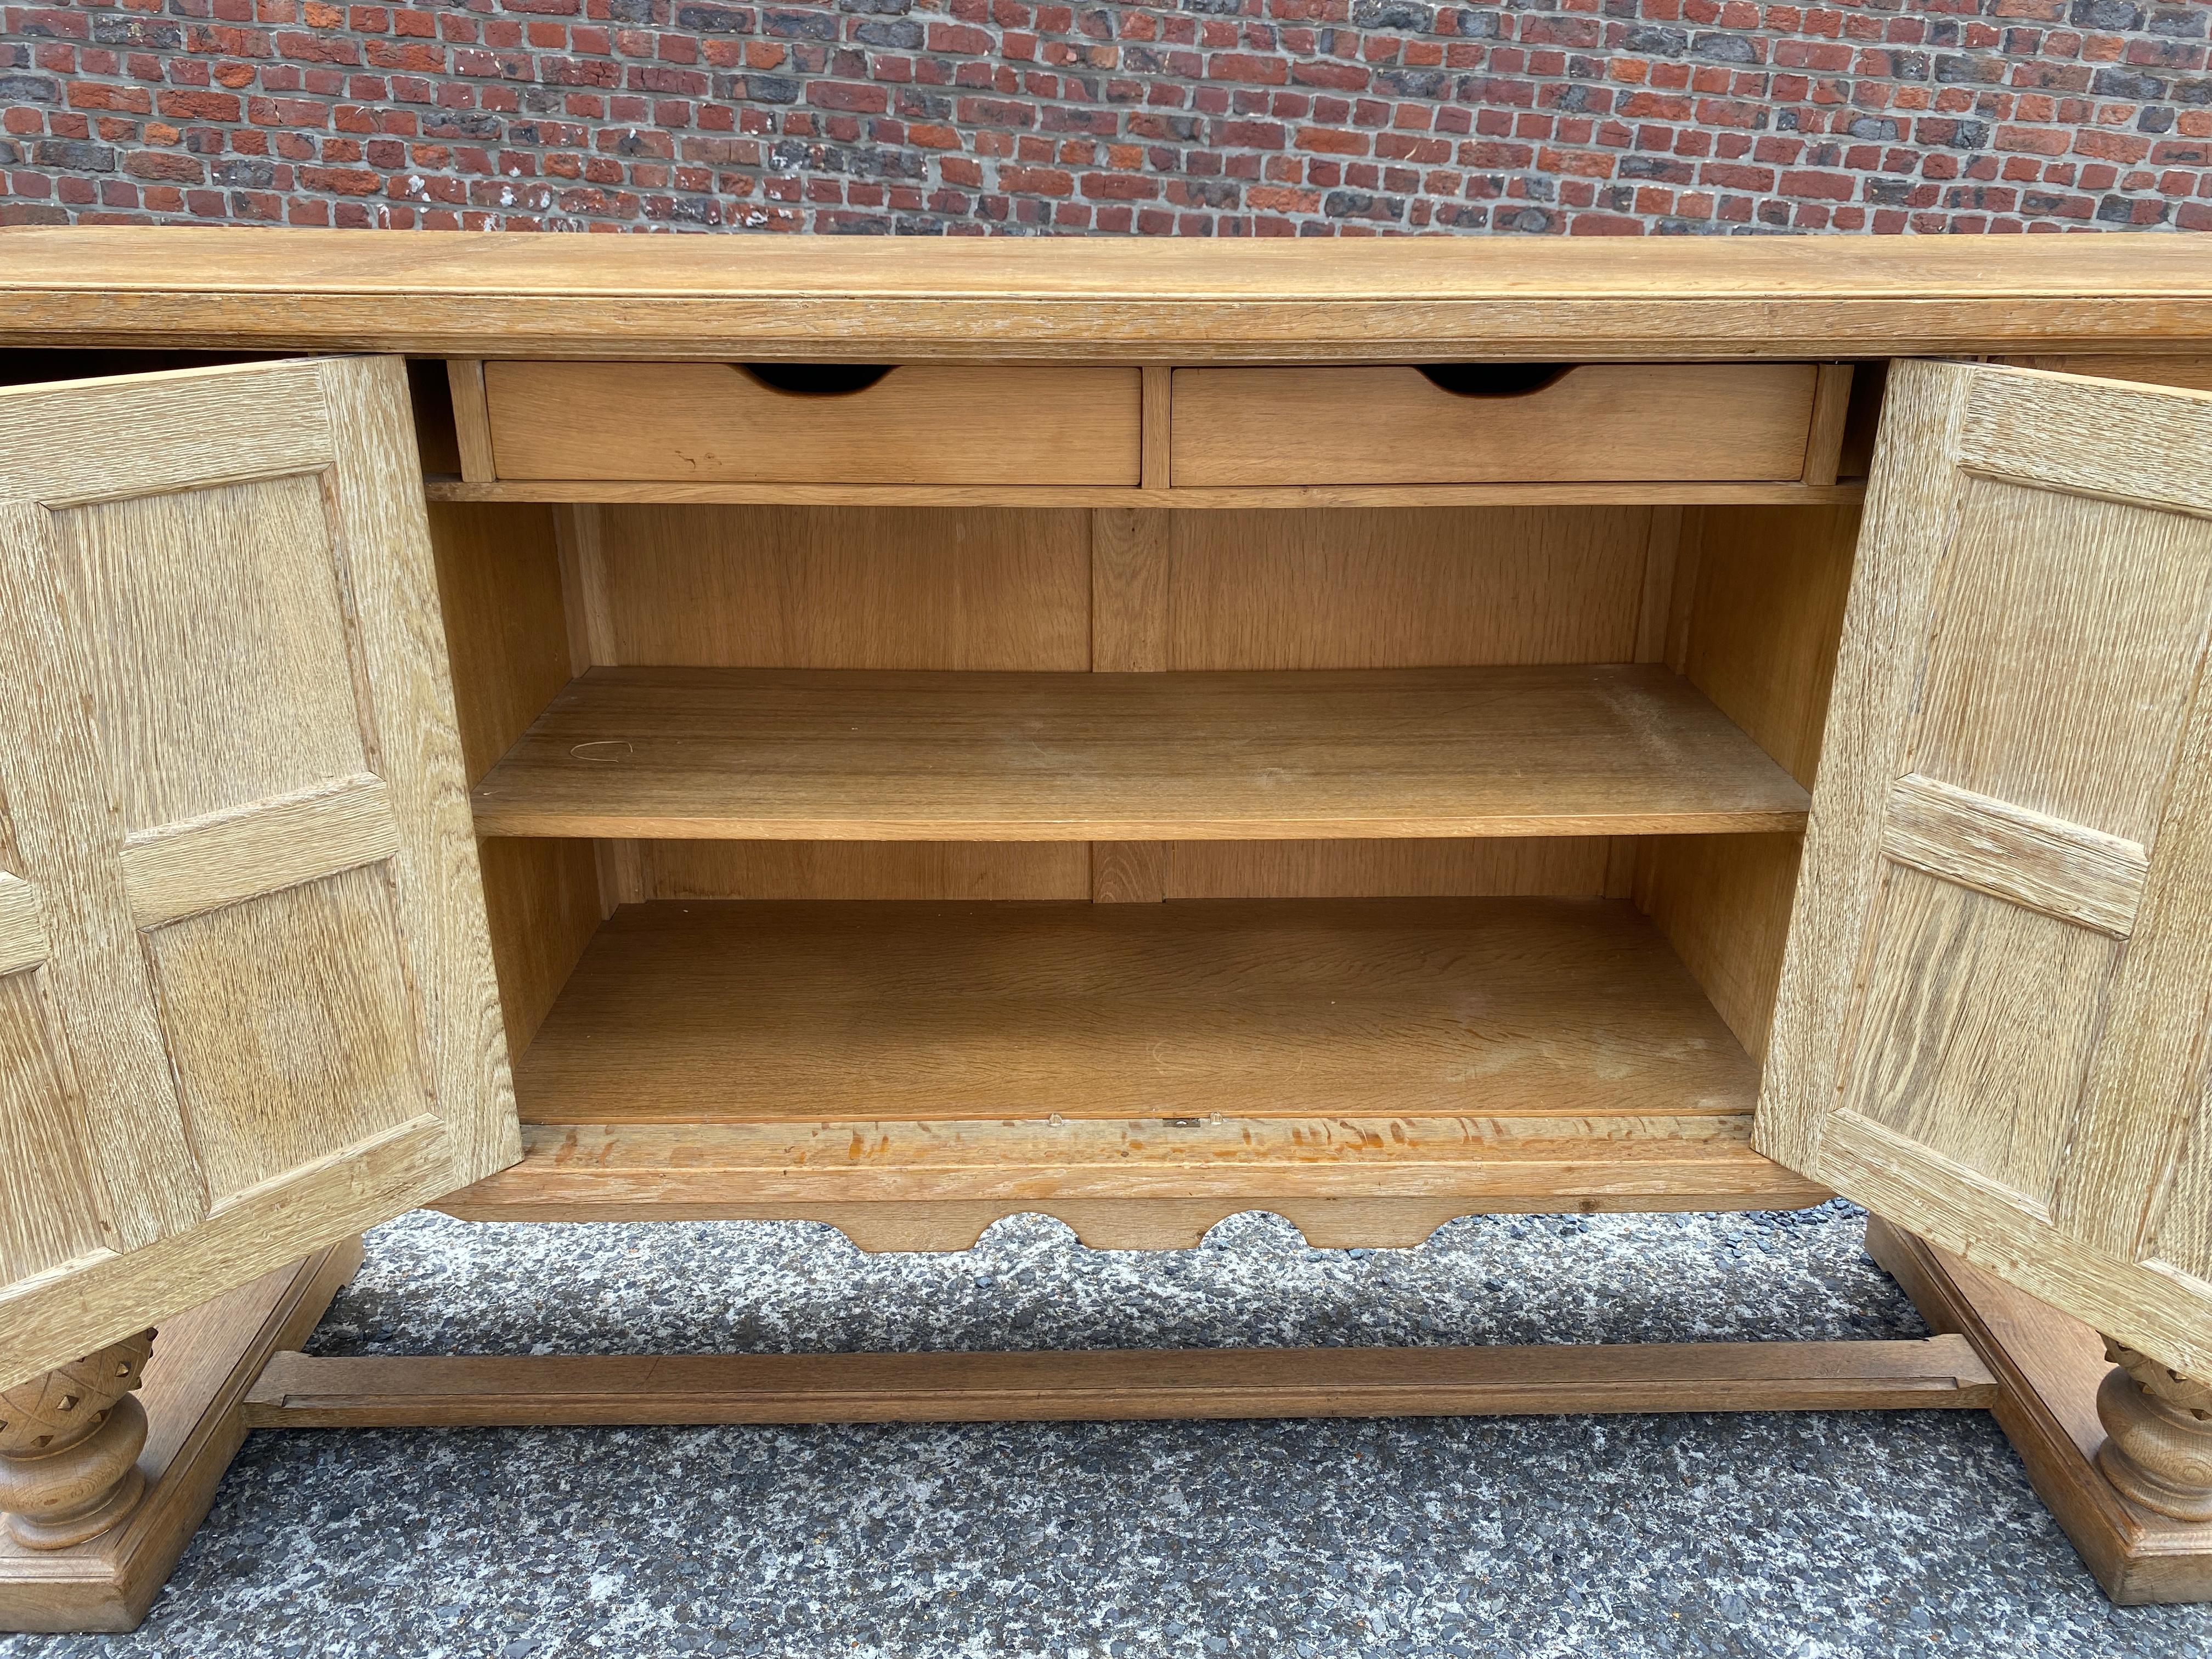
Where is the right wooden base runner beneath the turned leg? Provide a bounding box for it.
[1867,1217,2212,1606]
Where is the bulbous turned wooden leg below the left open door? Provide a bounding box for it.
[0,1331,153,1550]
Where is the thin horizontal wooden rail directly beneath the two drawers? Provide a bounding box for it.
[422,478,1867,511]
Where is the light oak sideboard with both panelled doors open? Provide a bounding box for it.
[0,228,2212,1628]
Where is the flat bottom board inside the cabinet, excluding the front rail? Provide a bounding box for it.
[517,898,1752,1124]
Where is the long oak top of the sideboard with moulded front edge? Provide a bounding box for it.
[0,228,2212,363]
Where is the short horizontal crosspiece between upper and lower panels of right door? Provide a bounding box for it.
[1882,772,2150,938]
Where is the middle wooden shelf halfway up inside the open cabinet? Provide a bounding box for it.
[476,664,1809,840]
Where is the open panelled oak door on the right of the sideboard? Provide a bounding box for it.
[1758,363,2212,1378]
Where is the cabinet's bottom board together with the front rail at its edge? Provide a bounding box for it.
[442,898,1827,1248]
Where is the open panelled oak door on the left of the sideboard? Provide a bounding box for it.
[0,358,520,1387]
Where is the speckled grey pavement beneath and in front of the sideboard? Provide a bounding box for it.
[0,1203,2212,1659]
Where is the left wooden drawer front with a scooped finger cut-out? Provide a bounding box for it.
[484,363,1144,484]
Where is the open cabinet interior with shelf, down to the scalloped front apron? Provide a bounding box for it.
[429,462,1858,1248]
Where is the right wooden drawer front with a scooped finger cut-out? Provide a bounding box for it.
[1170,363,1820,484]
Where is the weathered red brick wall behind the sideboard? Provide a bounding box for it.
[0,0,2212,234]
